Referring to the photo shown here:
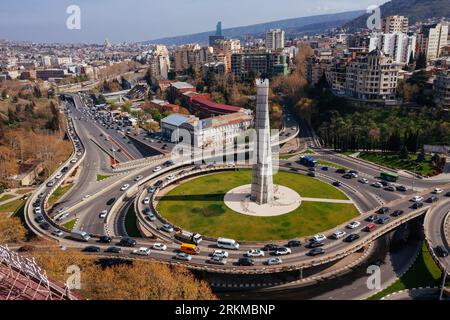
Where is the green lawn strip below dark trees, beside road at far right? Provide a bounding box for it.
[359,152,434,176]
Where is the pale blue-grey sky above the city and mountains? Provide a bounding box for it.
[0,0,386,43]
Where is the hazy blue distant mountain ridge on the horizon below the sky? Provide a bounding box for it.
[144,10,364,45]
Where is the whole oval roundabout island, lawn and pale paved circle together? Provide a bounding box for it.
[153,168,358,241]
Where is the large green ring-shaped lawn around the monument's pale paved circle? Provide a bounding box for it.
[158,170,358,241]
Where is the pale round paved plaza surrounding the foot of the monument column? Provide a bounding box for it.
[224,184,302,217]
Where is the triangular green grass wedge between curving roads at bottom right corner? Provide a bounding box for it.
[369,243,441,300]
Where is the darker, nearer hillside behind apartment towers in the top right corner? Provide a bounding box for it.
[344,0,450,31]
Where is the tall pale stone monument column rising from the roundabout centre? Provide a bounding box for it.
[251,79,274,205]
